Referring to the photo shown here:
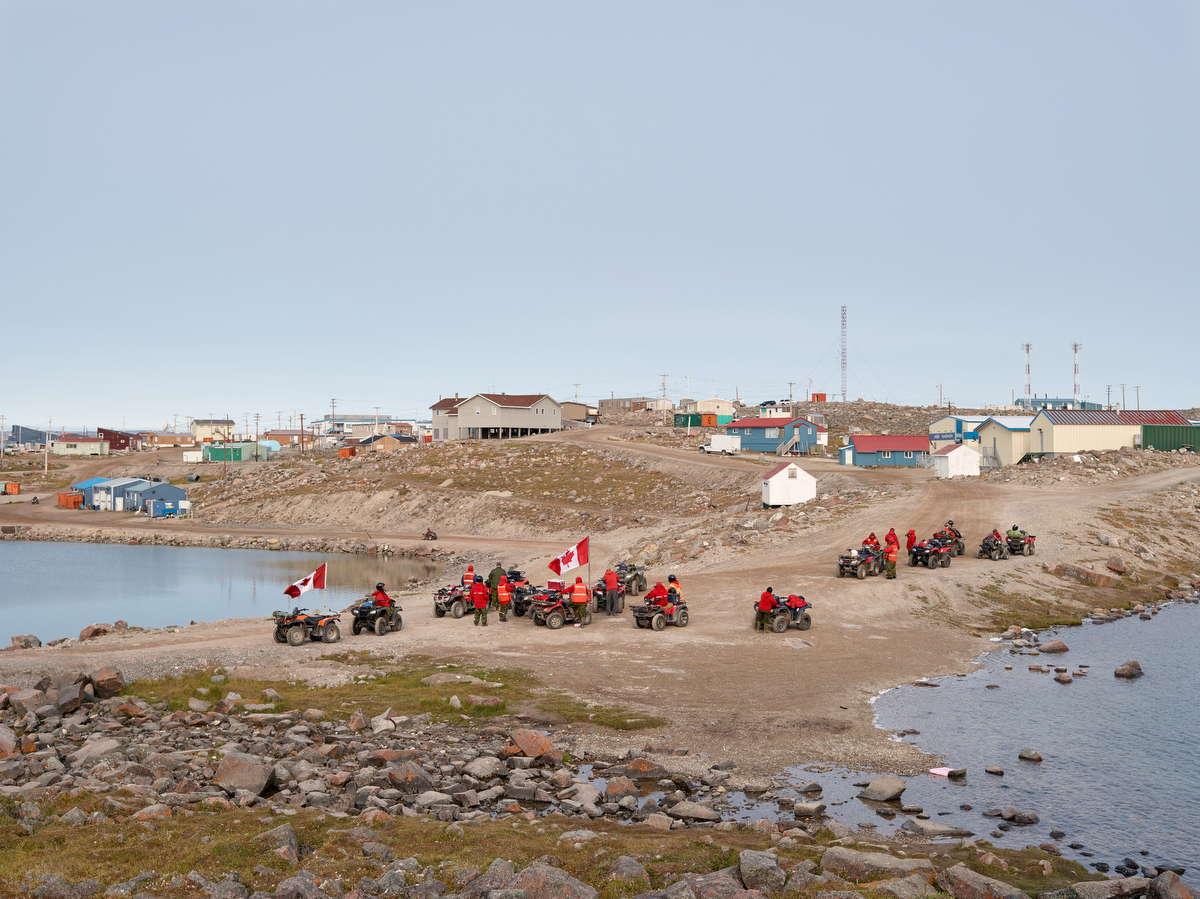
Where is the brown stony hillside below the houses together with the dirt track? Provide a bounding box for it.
[0,428,1200,772]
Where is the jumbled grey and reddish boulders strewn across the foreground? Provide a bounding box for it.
[0,669,1200,899]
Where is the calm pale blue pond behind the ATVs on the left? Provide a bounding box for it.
[0,540,437,643]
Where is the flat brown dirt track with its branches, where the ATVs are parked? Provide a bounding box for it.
[0,439,1200,772]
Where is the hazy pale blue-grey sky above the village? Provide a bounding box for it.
[0,0,1200,428]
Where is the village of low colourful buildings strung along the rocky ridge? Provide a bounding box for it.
[0,394,1200,517]
